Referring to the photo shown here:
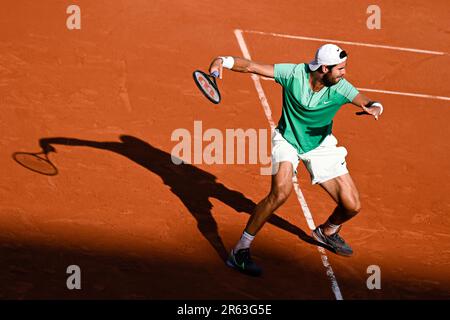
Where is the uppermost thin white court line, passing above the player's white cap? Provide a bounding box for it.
[243,30,447,56]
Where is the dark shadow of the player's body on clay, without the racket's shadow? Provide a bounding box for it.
[39,135,317,260]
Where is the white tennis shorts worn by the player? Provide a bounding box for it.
[272,130,348,184]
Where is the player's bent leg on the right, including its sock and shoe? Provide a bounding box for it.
[313,173,361,256]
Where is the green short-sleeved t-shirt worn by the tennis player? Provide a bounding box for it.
[274,63,359,154]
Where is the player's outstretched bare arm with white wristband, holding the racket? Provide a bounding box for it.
[209,56,274,79]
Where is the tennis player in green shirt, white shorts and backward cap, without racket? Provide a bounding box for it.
[210,44,383,276]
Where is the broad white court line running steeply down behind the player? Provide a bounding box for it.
[234,29,343,300]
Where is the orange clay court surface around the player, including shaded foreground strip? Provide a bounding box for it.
[0,0,450,300]
